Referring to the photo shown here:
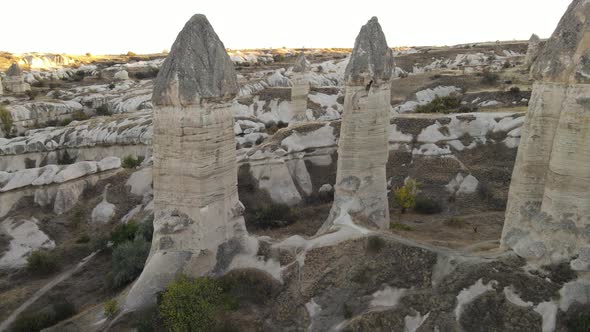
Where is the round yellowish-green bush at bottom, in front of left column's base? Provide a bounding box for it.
[159,276,238,332]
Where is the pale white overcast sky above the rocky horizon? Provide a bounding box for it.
[0,0,571,54]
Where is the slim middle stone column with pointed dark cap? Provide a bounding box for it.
[319,17,393,233]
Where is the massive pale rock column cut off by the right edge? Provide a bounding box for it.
[502,0,590,270]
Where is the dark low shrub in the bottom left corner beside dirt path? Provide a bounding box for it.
[11,301,76,332]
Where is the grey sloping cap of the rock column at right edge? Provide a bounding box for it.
[531,0,590,84]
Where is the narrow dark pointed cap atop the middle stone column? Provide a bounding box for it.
[344,17,394,85]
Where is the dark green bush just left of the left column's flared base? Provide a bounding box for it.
[111,237,150,289]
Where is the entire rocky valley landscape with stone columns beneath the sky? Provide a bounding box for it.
[0,0,590,332]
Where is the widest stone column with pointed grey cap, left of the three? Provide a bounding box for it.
[125,15,246,310]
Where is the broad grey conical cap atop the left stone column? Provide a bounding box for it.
[152,14,238,106]
